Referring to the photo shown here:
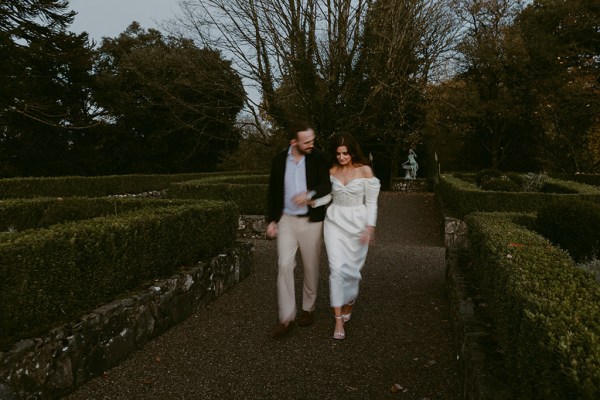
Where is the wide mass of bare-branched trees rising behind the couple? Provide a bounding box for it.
[169,0,455,181]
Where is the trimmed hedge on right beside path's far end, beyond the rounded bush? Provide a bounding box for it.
[435,175,600,218]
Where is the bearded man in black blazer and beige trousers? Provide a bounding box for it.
[266,122,331,338]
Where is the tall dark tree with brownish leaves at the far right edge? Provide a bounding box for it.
[515,0,600,173]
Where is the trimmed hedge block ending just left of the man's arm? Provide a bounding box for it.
[167,175,269,215]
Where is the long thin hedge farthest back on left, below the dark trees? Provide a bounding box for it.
[0,171,247,199]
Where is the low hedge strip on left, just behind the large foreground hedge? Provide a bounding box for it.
[0,197,193,233]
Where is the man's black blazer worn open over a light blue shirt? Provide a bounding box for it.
[266,149,331,224]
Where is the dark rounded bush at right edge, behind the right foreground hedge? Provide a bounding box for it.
[536,200,600,262]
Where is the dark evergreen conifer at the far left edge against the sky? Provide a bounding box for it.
[0,0,94,177]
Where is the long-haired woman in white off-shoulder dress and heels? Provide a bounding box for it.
[311,134,381,340]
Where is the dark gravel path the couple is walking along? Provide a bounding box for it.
[66,192,461,400]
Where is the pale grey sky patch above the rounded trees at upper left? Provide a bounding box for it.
[69,0,179,43]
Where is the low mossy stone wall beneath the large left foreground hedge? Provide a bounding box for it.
[0,242,253,400]
